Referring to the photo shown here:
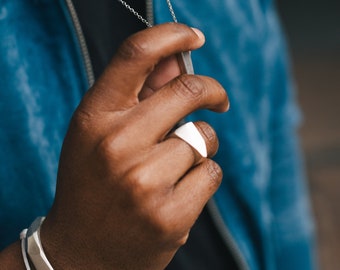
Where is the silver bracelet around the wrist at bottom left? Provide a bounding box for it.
[20,217,53,270]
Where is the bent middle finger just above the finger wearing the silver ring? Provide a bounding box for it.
[124,75,229,143]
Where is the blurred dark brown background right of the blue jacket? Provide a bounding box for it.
[277,0,340,270]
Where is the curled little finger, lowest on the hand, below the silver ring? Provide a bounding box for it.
[167,159,223,228]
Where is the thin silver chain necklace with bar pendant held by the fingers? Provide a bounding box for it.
[117,0,194,74]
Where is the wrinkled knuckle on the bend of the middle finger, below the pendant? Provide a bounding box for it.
[174,74,207,102]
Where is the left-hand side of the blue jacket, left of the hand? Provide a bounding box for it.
[0,0,87,248]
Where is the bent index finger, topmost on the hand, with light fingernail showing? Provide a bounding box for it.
[84,23,204,111]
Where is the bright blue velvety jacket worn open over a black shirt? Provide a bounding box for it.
[0,0,314,270]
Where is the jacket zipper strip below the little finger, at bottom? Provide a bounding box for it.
[207,199,250,270]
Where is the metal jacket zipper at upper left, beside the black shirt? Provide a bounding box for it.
[65,0,95,87]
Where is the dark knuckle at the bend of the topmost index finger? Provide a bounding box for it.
[117,37,148,61]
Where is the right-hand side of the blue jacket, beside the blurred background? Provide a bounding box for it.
[155,0,315,270]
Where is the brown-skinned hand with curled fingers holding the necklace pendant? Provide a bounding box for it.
[0,23,229,270]
